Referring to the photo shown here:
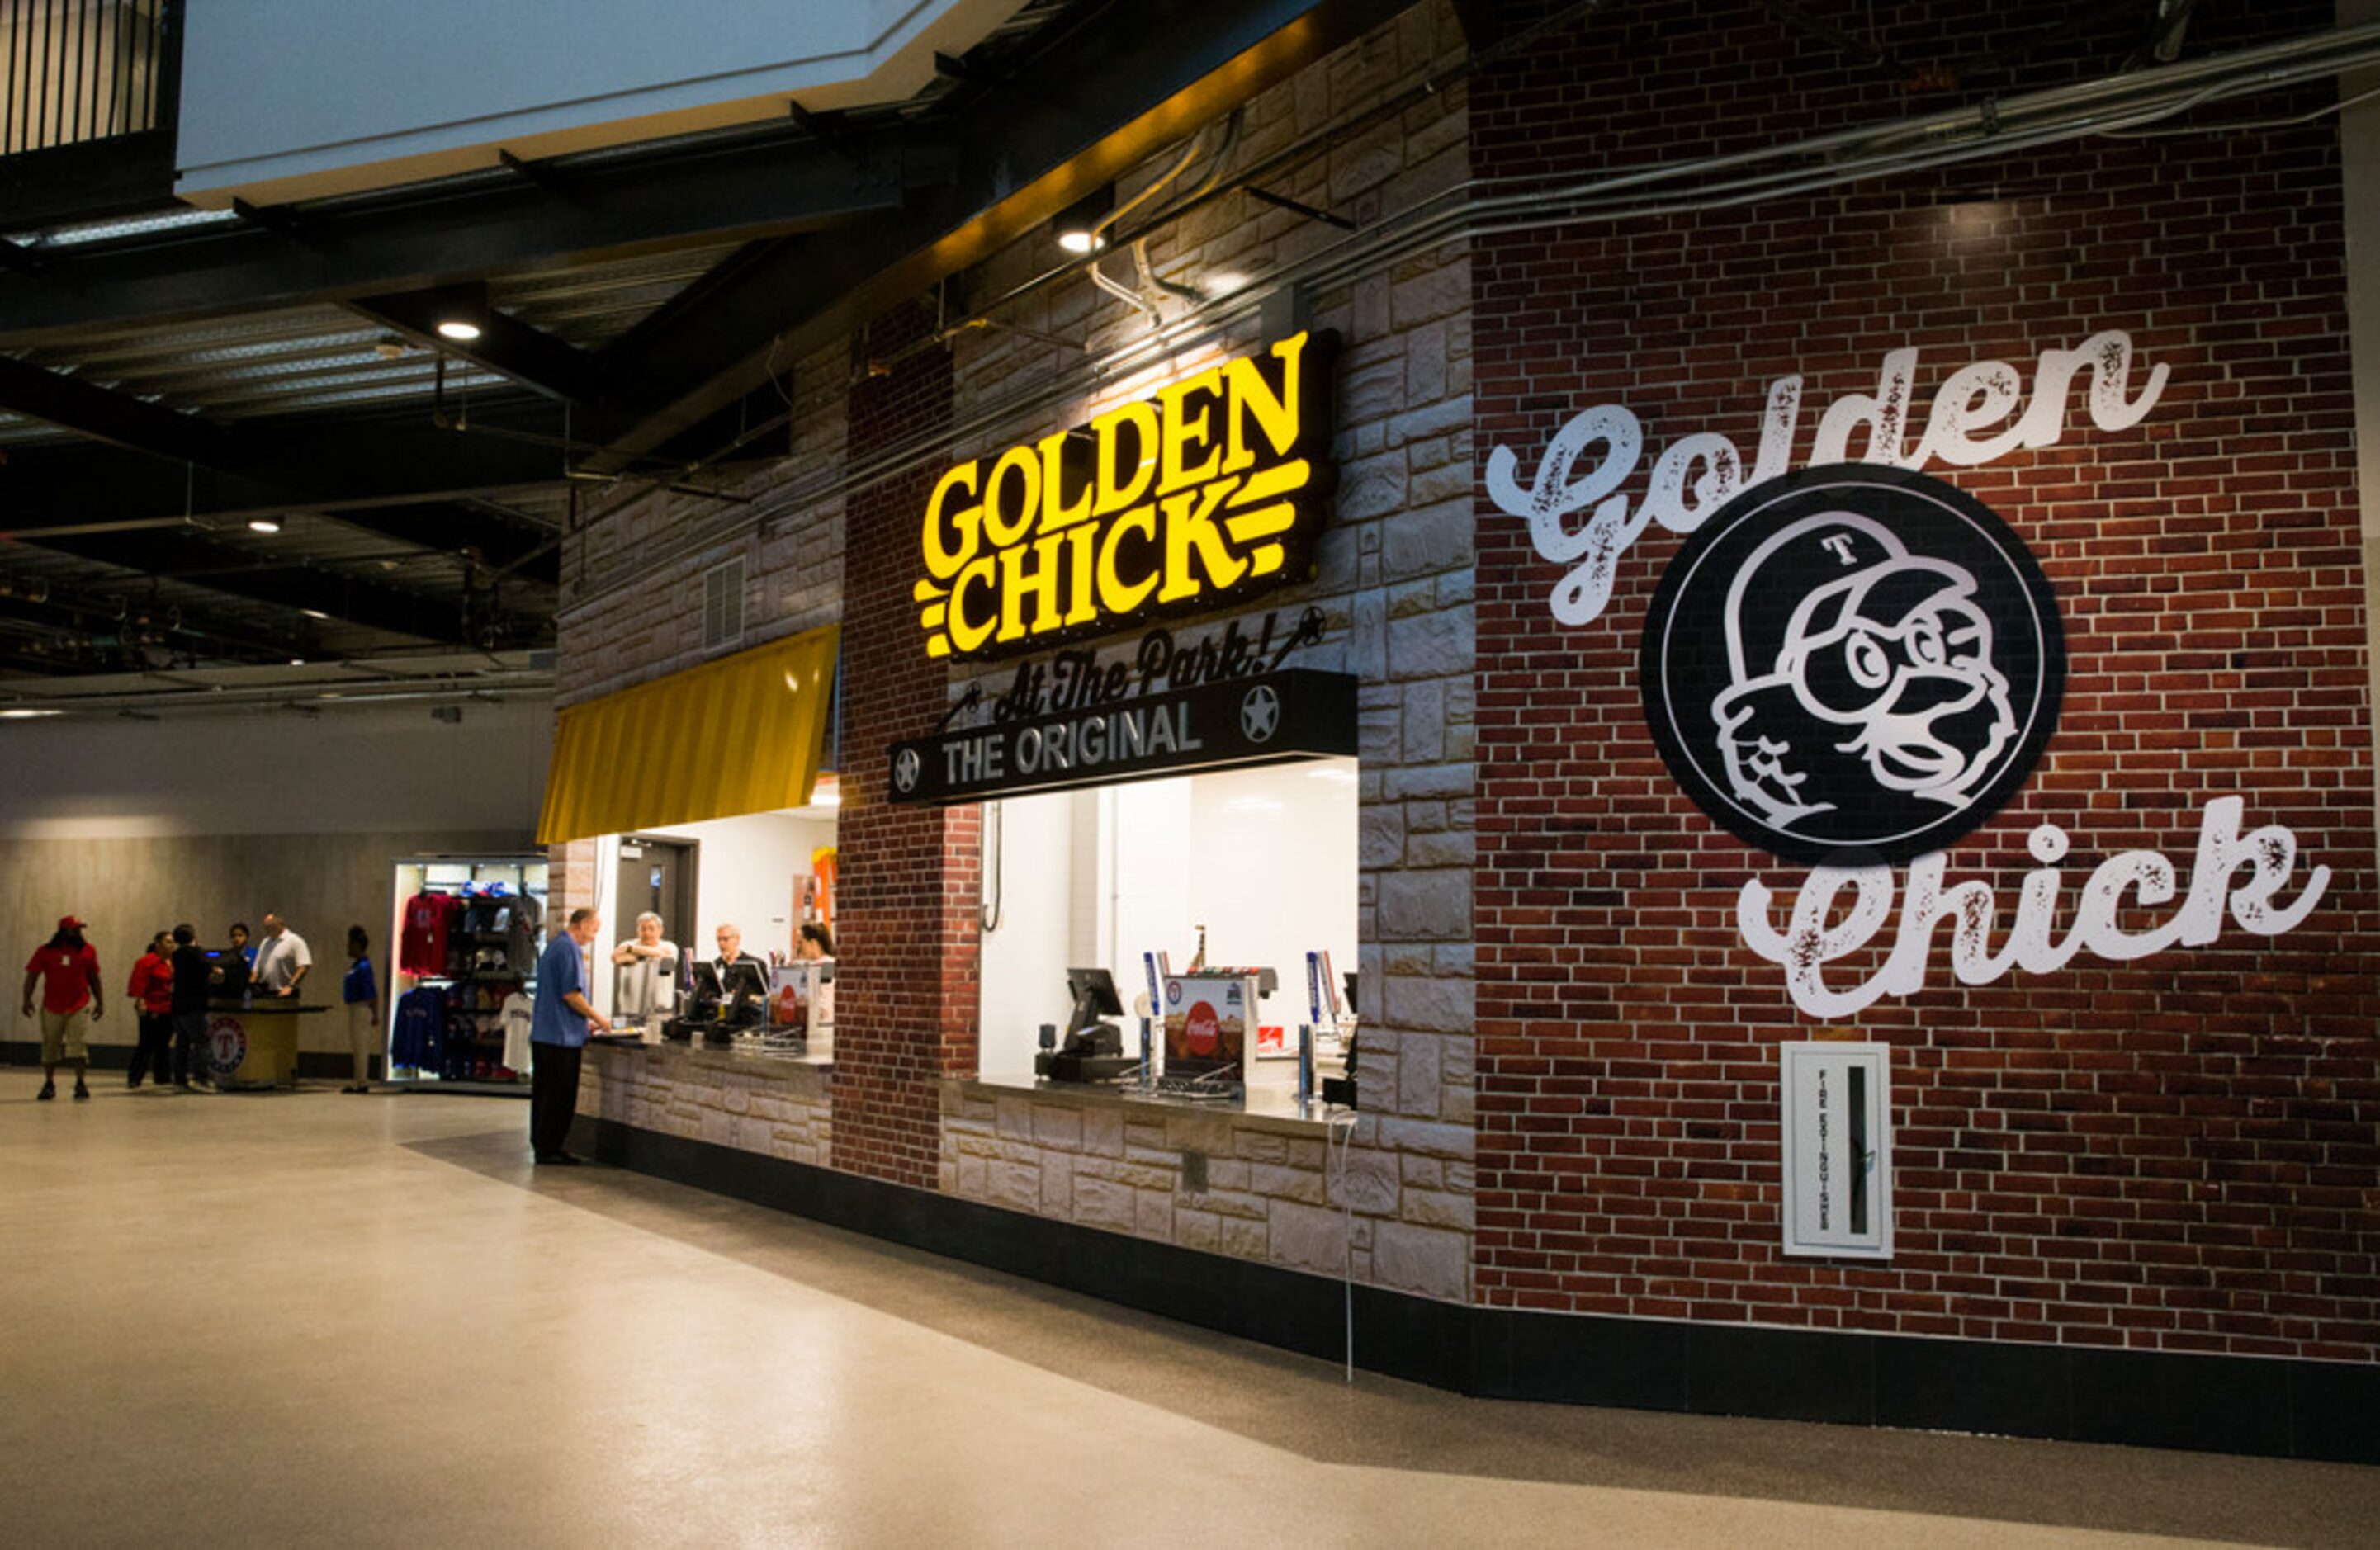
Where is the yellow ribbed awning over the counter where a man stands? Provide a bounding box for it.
[538,626,838,845]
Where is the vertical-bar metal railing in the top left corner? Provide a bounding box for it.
[0,0,181,157]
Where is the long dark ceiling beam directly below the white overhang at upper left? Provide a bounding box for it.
[0,121,952,345]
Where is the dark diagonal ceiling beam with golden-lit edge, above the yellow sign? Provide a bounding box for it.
[598,0,1412,455]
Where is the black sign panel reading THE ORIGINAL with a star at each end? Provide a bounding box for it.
[887,667,1354,805]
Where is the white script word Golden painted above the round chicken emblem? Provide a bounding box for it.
[1485,328,2168,626]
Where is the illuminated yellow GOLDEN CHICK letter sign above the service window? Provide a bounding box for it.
[914,333,1337,657]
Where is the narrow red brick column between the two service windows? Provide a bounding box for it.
[833,310,978,1188]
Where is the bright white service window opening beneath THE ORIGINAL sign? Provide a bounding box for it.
[978,757,1359,1085]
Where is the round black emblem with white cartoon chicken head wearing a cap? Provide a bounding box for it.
[1638,466,2065,862]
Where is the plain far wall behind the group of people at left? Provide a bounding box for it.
[0,702,552,1066]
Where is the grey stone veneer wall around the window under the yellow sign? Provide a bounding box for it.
[918,5,1474,1300]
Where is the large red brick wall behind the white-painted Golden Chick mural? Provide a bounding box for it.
[1471,5,2380,1362]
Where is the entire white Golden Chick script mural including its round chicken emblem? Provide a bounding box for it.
[1485,328,2330,1019]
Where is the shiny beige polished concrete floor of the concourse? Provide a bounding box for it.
[0,1069,2380,1548]
